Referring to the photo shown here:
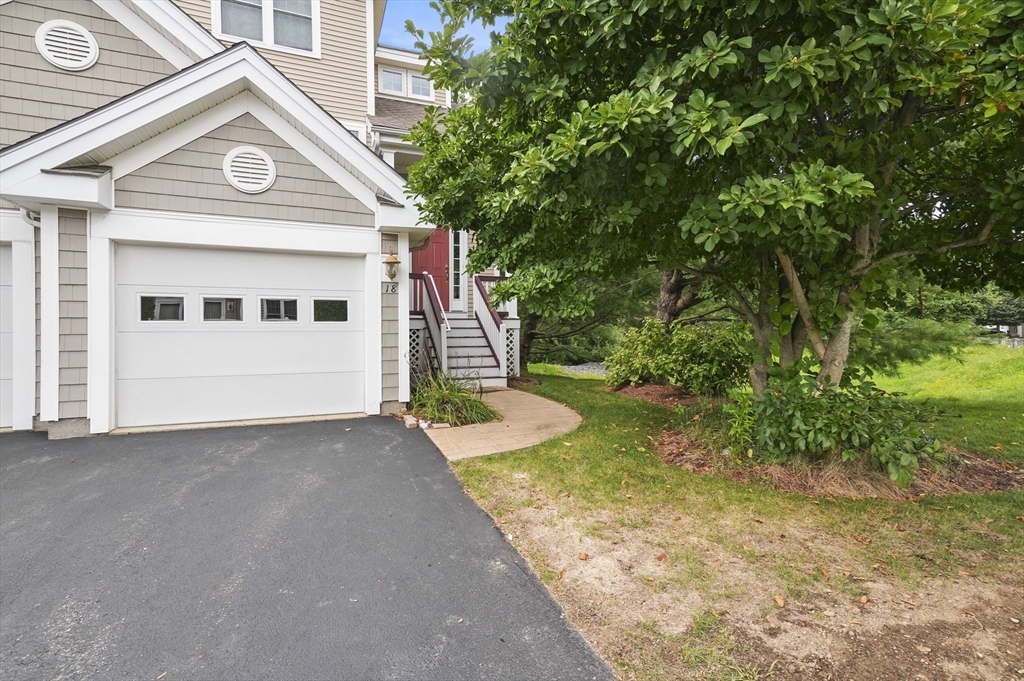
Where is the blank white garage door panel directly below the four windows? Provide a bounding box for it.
[118,329,366,379]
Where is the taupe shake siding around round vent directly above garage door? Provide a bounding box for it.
[114,114,374,227]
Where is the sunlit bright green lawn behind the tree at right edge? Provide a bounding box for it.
[877,344,1024,463]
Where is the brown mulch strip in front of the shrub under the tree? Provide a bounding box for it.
[657,431,1024,501]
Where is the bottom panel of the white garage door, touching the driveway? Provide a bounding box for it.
[118,373,364,427]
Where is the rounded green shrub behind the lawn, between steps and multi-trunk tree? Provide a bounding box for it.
[606,318,751,395]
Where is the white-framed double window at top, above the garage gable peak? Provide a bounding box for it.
[211,0,321,56]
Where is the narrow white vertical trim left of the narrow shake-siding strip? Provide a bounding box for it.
[39,206,60,421]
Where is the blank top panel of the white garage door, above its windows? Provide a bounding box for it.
[118,245,365,291]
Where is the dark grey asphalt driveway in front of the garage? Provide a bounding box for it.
[0,418,612,681]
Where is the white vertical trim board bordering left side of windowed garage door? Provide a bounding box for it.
[88,231,117,433]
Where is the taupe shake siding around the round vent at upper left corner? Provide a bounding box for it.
[0,0,177,147]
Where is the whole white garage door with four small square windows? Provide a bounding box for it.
[116,244,366,427]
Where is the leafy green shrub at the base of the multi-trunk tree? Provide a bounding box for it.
[730,373,945,487]
